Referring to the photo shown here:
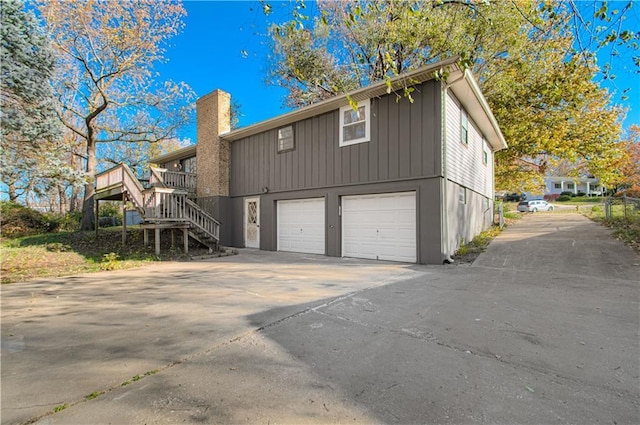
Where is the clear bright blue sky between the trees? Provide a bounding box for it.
[157,0,640,143]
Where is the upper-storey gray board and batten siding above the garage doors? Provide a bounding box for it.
[229,81,441,197]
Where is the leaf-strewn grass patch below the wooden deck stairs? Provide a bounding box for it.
[0,227,210,284]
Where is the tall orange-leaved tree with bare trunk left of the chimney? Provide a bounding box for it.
[39,0,194,230]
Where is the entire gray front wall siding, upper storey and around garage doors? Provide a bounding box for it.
[229,80,442,263]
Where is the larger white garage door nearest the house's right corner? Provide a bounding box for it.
[342,192,417,263]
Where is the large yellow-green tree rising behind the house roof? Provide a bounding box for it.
[270,0,637,190]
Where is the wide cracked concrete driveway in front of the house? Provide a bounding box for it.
[2,214,640,424]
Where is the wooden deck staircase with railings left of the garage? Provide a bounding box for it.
[95,164,220,254]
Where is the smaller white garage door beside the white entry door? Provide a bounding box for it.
[278,198,325,254]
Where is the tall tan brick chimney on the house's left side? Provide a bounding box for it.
[196,90,231,199]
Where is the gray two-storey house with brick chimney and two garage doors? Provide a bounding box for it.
[152,59,506,264]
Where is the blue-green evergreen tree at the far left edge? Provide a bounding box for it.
[0,0,78,201]
